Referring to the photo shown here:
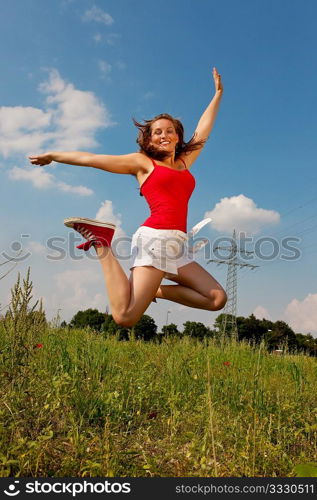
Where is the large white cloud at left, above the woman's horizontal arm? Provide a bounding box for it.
[0,69,114,157]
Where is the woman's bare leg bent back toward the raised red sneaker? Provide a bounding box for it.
[96,247,165,326]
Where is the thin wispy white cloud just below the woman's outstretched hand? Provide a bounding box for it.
[9,167,93,196]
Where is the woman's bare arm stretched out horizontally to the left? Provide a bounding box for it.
[29,151,147,175]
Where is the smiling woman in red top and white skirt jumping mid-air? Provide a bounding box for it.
[29,68,227,327]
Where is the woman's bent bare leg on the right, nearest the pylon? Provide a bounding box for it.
[155,262,227,311]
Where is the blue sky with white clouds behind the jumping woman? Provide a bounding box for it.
[0,0,317,335]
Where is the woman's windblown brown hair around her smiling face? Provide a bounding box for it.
[133,113,206,161]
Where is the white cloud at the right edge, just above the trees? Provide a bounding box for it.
[285,293,317,333]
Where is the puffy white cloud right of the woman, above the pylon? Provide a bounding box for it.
[205,194,280,234]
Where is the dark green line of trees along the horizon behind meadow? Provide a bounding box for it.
[61,309,317,356]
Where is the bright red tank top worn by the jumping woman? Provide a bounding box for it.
[140,160,195,233]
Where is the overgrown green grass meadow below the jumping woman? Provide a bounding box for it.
[0,325,317,477]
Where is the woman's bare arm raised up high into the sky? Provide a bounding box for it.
[181,68,223,166]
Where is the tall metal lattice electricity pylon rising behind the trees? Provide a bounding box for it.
[207,230,259,343]
